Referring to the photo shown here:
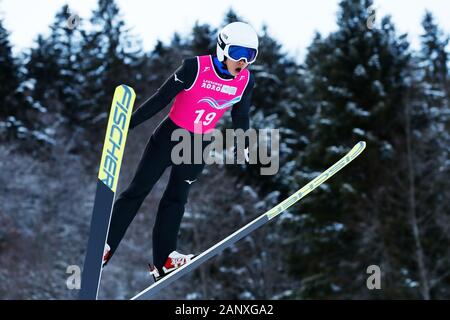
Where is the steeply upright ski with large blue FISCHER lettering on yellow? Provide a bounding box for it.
[79,85,136,300]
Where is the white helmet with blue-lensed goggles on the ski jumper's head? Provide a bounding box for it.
[217,22,259,63]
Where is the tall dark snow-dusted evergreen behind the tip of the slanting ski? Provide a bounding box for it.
[291,0,416,298]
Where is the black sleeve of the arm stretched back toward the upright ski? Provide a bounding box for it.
[130,58,198,129]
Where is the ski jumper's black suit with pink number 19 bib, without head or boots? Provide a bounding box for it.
[107,56,254,269]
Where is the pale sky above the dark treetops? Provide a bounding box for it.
[0,0,450,57]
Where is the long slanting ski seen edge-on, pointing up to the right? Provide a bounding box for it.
[131,141,366,300]
